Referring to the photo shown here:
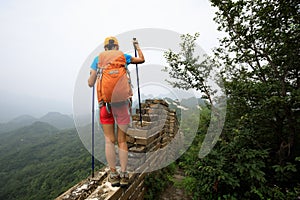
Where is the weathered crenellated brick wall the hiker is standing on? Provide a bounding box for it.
[56,99,184,200]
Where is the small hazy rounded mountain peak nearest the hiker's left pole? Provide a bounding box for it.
[39,112,75,129]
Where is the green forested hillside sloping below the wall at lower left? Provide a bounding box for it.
[0,122,100,200]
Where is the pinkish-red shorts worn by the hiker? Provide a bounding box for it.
[99,103,130,125]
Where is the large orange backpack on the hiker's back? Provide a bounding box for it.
[97,50,133,103]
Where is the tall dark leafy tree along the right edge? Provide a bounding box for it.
[211,0,300,187]
